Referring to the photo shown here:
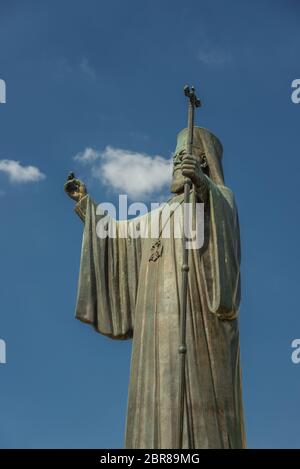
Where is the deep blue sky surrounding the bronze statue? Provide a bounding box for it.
[0,0,300,448]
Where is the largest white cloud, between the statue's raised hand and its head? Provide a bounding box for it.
[75,146,172,198]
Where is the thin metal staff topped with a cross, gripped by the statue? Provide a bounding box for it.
[178,85,201,449]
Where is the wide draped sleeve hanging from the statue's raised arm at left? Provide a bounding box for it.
[75,196,140,339]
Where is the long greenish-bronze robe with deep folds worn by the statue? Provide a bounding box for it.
[76,178,245,449]
